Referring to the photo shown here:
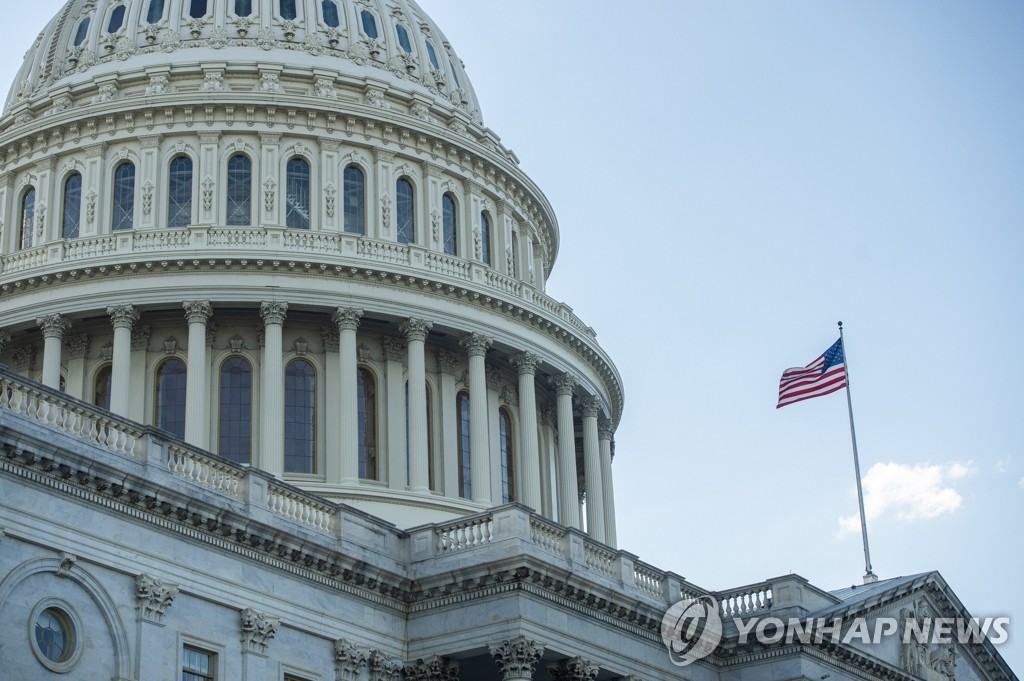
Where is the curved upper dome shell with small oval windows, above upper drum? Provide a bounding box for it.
[5,0,480,123]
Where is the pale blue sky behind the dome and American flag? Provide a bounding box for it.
[0,0,1024,672]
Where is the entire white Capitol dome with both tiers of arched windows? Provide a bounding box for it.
[0,0,623,545]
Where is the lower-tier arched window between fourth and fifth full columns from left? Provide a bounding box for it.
[285,359,316,473]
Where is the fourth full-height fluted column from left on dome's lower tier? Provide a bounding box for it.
[258,302,288,477]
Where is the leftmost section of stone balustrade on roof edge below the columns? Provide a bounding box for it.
[0,369,145,459]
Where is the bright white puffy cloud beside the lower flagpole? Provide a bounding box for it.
[839,462,970,537]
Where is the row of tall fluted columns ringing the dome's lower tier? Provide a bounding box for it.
[22,300,616,546]
